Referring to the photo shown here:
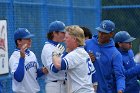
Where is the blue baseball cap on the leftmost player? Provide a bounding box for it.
[14,28,34,40]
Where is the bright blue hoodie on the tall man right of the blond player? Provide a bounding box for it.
[85,37,125,93]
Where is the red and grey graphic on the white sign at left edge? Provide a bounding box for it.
[0,25,5,51]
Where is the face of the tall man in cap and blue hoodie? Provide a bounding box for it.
[98,31,112,44]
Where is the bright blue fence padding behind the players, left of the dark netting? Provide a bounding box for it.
[0,0,101,93]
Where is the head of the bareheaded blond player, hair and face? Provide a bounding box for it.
[64,25,85,51]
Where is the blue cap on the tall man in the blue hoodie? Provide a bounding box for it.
[96,20,115,33]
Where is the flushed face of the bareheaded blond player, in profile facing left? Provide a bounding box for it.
[64,32,76,51]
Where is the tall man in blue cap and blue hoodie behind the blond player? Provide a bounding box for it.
[85,20,125,93]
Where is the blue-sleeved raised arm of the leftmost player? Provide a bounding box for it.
[14,57,25,82]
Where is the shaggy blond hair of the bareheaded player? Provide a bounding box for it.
[66,25,85,46]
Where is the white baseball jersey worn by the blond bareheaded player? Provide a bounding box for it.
[63,47,95,93]
